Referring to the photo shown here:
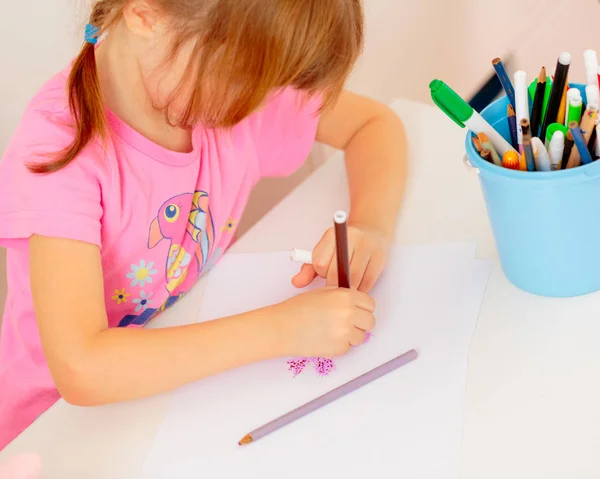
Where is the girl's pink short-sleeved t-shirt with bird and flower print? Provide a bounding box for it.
[0,64,318,449]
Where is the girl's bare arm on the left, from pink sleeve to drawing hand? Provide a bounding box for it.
[29,236,374,406]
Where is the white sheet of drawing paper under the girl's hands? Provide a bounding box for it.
[143,246,490,479]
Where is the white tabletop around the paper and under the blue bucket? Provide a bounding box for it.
[0,100,600,479]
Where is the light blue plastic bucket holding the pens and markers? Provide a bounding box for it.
[466,85,600,297]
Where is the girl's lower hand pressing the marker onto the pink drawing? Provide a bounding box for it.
[272,288,375,358]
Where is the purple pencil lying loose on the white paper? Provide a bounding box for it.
[239,349,419,446]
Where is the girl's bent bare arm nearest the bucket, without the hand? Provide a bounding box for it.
[317,92,408,238]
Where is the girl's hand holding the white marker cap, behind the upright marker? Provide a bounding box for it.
[292,226,391,293]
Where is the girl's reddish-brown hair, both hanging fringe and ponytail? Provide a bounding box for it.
[30,0,363,173]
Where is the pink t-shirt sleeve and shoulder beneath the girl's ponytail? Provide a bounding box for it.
[0,67,111,251]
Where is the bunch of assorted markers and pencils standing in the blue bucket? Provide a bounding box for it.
[430,50,600,171]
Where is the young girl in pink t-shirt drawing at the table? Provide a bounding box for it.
[0,0,406,448]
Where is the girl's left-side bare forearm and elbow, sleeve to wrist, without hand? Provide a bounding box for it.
[30,236,285,405]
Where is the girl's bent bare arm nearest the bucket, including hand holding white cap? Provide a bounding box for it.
[292,92,407,292]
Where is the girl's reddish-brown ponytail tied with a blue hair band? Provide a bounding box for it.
[29,0,115,173]
